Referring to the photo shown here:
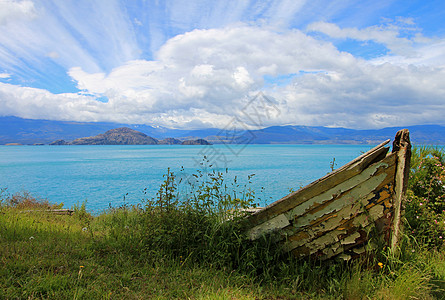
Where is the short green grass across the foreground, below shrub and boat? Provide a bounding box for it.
[0,198,445,299]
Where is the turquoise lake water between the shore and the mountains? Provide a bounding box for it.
[0,145,373,213]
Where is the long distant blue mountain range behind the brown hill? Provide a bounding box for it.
[0,117,445,145]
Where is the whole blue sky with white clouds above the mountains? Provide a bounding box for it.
[0,0,445,129]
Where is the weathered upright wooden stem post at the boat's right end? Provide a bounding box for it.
[390,129,411,253]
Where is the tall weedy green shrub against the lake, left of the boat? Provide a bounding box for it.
[141,169,254,266]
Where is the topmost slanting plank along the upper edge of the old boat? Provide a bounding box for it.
[249,140,389,227]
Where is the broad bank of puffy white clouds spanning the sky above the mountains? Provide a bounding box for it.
[0,23,445,128]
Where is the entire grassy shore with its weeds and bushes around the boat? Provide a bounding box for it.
[0,148,445,299]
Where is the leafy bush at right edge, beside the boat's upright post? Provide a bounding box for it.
[405,147,445,248]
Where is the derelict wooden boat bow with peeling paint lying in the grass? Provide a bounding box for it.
[247,129,411,260]
